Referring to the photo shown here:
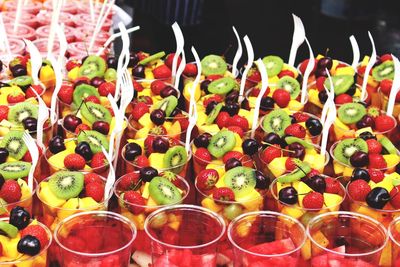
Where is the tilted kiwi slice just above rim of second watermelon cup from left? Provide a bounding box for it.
[149,176,182,205]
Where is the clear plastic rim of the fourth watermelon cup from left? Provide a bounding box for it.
[306,211,389,257]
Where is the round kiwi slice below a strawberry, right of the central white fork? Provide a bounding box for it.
[262,109,292,136]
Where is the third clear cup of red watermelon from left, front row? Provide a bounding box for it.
[228,211,306,267]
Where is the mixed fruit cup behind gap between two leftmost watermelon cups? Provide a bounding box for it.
[114,172,190,266]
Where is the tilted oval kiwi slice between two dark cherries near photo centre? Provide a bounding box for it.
[207,130,236,158]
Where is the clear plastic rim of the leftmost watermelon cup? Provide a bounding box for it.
[53,211,137,258]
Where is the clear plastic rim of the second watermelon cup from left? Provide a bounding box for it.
[144,205,226,249]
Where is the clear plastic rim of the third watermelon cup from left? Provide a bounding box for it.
[227,211,307,258]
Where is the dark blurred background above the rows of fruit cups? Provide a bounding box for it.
[117,0,400,63]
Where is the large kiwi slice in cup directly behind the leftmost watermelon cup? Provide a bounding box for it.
[49,171,84,199]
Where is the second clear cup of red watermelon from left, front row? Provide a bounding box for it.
[145,205,226,267]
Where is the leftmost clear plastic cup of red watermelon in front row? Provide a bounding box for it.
[54,211,136,267]
